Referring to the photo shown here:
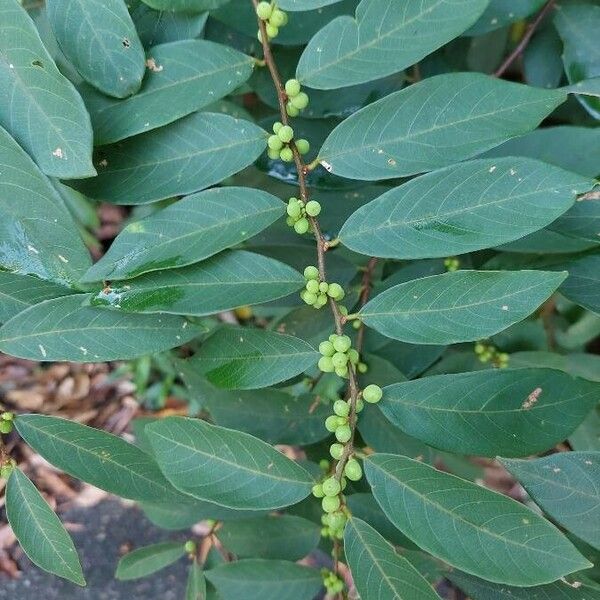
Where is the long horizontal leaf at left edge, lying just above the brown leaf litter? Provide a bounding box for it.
[0,294,201,362]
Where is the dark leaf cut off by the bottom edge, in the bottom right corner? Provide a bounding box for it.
[448,570,599,600]
